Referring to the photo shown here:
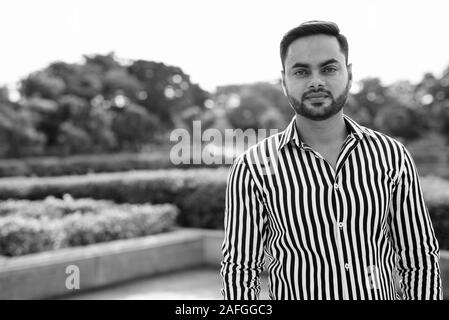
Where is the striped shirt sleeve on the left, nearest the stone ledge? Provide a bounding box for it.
[221,157,265,300]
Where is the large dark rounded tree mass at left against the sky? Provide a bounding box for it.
[7,53,209,157]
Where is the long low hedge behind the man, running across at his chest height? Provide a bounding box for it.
[0,168,449,249]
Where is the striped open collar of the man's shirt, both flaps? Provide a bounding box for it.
[278,114,376,151]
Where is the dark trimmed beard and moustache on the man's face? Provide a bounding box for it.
[287,81,350,121]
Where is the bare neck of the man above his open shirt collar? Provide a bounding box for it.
[296,111,348,147]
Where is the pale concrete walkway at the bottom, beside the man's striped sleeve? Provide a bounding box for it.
[63,268,268,300]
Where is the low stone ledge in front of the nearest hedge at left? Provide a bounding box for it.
[0,229,204,299]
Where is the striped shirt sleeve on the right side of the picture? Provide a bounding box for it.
[390,145,443,300]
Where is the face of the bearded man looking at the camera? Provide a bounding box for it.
[282,35,351,121]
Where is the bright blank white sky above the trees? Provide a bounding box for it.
[0,0,449,91]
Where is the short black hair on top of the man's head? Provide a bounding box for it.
[280,20,349,68]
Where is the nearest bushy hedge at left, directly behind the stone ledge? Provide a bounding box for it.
[0,196,178,256]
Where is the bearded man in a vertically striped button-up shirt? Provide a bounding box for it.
[221,21,442,299]
